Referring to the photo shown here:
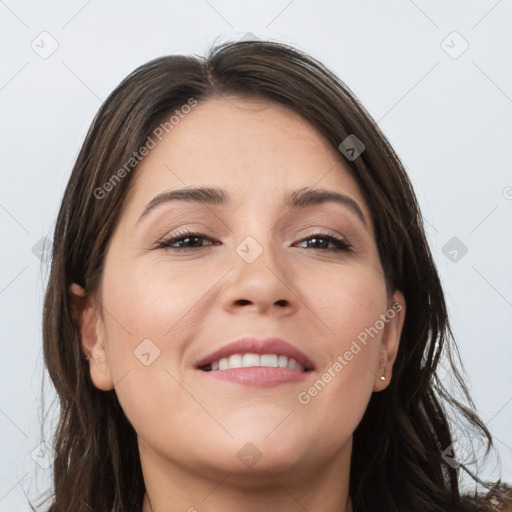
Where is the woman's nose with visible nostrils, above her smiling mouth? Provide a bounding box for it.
[222,237,300,316]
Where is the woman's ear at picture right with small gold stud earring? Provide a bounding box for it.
[373,290,406,391]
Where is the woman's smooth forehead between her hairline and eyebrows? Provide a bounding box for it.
[124,96,369,222]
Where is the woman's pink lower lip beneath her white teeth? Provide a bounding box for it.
[199,366,313,387]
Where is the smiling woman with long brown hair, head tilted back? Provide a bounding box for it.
[34,41,510,512]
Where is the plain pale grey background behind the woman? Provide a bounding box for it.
[0,0,512,511]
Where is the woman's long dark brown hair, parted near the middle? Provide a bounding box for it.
[34,41,505,512]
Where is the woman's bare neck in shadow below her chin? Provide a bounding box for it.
[139,439,352,512]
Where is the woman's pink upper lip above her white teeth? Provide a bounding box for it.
[196,336,314,370]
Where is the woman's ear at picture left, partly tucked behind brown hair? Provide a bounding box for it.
[69,283,114,391]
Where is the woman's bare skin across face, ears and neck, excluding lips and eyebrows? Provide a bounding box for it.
[72,96,405,512]
